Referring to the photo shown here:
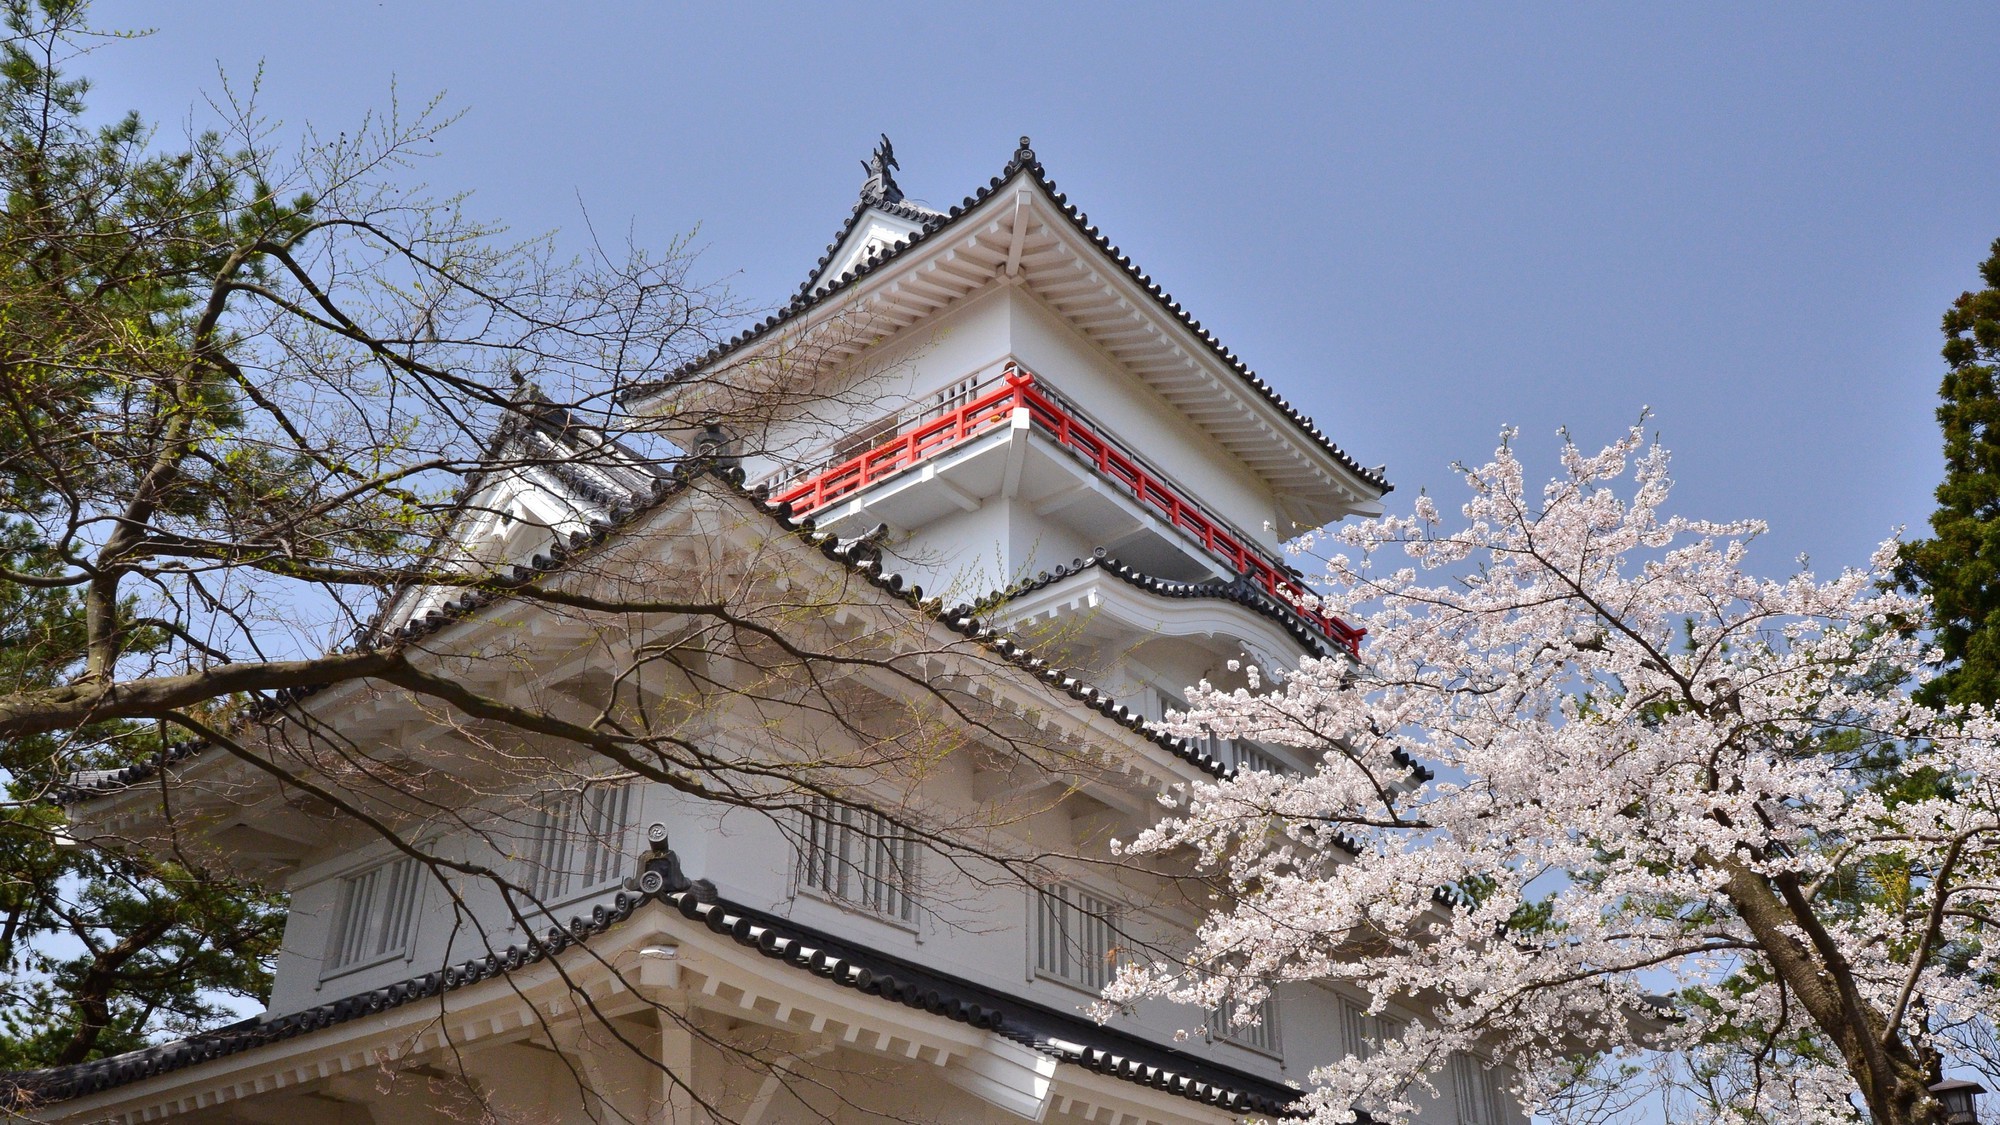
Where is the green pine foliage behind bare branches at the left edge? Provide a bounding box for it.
[0,0,284,1069]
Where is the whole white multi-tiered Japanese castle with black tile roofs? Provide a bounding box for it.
[18,138,1524,1125]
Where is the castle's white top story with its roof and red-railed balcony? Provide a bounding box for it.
[628,138,1390,647]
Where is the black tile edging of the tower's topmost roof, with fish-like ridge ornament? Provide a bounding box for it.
[620,136,1394,492]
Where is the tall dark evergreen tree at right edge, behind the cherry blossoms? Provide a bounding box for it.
[1898,238,2000,707]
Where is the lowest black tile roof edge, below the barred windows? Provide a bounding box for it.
[0,855,1298,1117]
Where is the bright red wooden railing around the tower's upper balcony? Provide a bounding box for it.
[772,362,1362,653]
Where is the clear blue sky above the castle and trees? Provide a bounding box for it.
[90,0,2000,571]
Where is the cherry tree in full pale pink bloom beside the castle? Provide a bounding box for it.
[1104,428,2000,1125]
